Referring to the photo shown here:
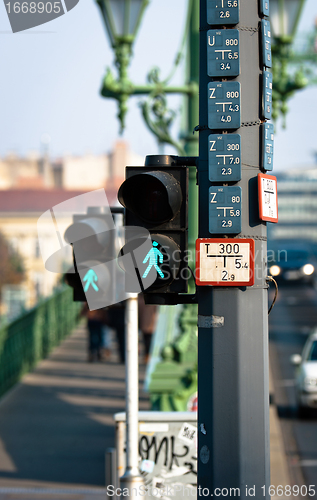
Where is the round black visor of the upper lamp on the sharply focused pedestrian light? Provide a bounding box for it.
[118,171,182,224]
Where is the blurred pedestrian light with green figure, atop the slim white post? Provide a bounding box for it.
[64,207,116,310]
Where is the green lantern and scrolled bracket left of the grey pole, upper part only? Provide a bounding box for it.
[96,0,198,148]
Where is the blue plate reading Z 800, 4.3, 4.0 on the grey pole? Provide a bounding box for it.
[208,82,241,130]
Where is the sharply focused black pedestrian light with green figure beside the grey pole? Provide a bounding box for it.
[118,155,190,303]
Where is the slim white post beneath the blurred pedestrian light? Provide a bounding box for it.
[120,294,143,498]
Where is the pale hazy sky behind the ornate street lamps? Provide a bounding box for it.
[0,0,317,173]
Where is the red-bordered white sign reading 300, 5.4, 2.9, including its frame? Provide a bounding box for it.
[196,238,254,286]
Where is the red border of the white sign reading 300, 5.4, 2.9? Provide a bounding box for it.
[195,238,254,286]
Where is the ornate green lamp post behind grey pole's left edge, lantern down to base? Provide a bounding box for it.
[96,0,199,410]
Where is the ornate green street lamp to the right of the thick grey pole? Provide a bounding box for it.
[270,0,308,124]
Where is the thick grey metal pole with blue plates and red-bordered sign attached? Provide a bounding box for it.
[196,0,273,498]
